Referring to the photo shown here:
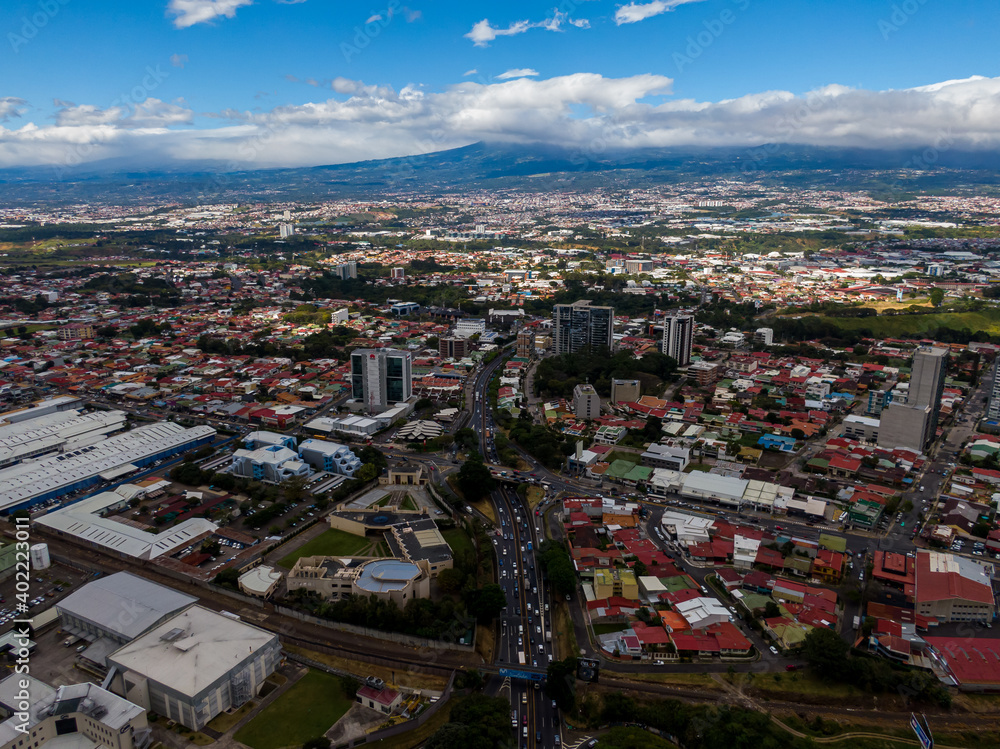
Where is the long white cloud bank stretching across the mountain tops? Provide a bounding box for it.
[0,73,1000,170]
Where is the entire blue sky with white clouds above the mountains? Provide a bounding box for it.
[0,0,1000,171]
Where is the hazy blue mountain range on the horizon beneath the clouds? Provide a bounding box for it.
[0,143,1000,205]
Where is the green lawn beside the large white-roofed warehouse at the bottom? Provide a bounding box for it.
[235,671,353,749]
